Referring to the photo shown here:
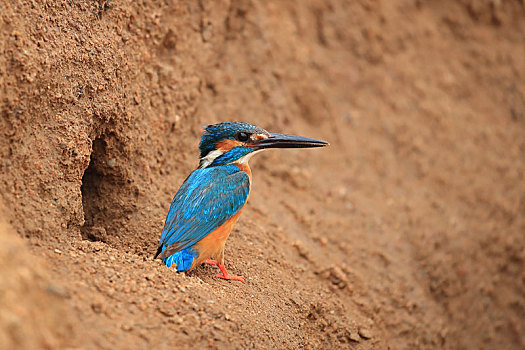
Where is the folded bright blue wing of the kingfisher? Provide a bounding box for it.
[155,165,250,259]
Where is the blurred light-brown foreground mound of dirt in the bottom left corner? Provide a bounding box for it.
[0,219,75,349]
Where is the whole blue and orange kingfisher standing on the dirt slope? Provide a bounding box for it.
[154,122,328,283]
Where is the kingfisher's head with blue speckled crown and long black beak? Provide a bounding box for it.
[199,122,328,168]
